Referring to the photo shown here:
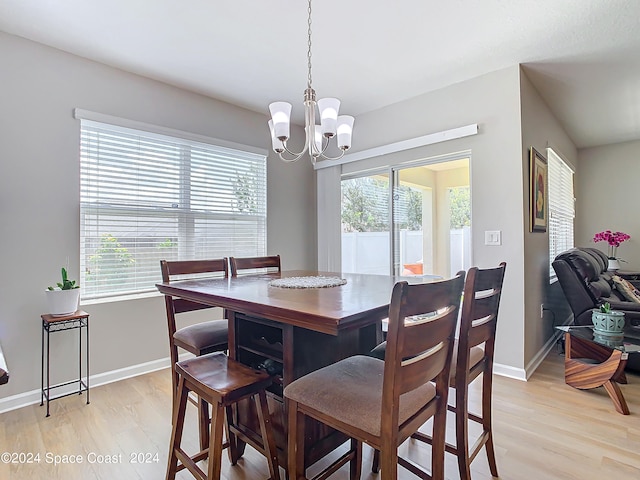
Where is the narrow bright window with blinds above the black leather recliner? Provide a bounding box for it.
[547,148,575,282]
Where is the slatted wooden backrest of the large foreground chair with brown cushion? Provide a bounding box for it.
[381,272,465,442]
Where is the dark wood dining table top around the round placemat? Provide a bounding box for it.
[156,270,412,335]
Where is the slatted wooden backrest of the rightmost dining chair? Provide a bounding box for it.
[456,262,507,380]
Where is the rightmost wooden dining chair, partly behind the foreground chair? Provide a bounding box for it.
[412,262,507,480]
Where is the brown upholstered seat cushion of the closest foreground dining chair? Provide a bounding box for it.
[284,355,436,437]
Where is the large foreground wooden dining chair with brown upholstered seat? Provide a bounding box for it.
[284,272,464,480]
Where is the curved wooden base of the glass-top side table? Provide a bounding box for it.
[564,333,629,415]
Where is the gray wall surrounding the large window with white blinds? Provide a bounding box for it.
[0,33,317,399]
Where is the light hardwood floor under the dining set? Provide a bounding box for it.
[0,352,640,480]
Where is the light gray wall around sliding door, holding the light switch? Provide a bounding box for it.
[343,66,528,376]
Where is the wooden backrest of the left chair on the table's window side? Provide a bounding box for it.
[160,257,229,336]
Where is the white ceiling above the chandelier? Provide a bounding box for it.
[0,0,640,148]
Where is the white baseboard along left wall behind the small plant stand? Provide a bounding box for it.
[0,353,193,413]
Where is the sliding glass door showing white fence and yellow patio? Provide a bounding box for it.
[342,158,471,278]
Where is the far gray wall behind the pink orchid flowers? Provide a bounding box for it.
[576,141,640,271]
